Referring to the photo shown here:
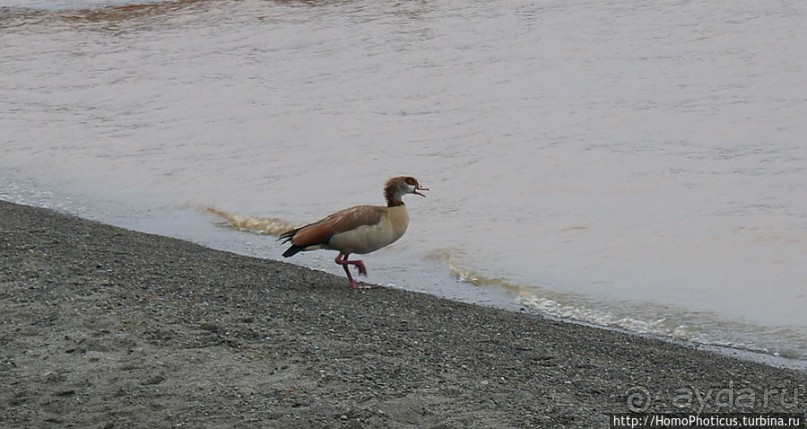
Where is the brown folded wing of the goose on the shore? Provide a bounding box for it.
[281,206,384,249]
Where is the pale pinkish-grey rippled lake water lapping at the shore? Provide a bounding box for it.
[0,0,807,359]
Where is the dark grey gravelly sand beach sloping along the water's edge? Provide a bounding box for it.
[0,202,807,428]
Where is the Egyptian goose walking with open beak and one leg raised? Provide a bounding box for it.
[280,176,429,289]
